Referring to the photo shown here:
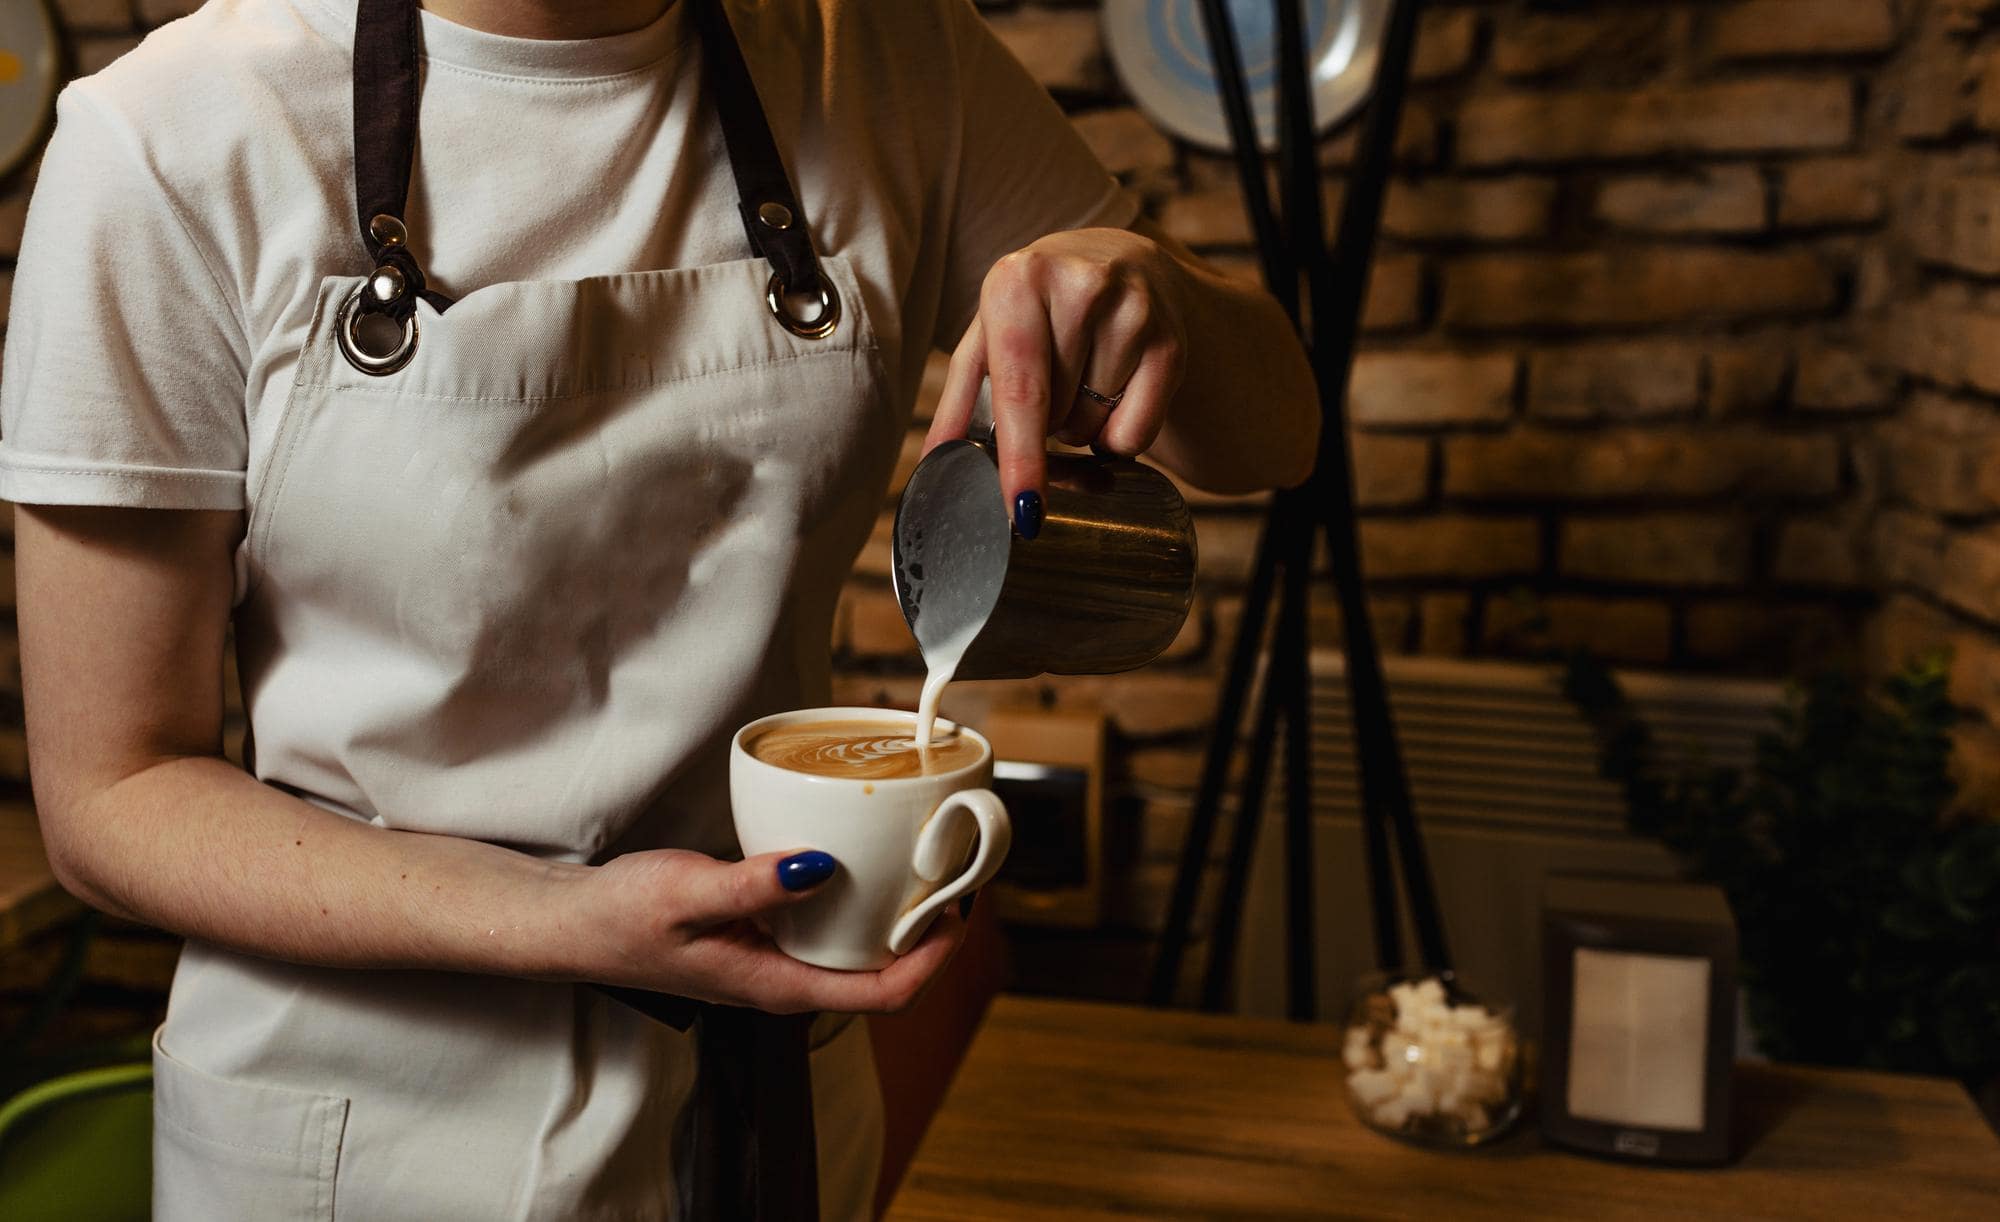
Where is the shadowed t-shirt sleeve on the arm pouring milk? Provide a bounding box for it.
[932,0,1140,348]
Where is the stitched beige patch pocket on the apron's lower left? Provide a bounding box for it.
[152,1034,348,1222]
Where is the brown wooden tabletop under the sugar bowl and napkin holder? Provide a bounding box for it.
[884,996,2000,1222]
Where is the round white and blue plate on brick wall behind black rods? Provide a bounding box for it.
[1104,0,1388,150]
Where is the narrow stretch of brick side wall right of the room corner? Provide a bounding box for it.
[1864,0,2000,824]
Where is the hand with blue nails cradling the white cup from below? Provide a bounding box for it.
[580,848,966,1014]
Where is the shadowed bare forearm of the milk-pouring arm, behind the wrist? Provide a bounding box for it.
[1152,230,1320,492]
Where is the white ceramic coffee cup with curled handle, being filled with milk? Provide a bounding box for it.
[730,708,1014,972]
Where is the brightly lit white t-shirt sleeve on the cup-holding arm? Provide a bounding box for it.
[0,86,248,510]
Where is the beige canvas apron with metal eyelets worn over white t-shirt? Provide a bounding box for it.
[154,2,902,1192]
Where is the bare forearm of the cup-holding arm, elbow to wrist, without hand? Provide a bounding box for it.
[44,756,594,978]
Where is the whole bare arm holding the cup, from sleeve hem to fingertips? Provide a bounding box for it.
[14,506,964,1014]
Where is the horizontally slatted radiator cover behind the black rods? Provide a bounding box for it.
[1236,650,1784,1032]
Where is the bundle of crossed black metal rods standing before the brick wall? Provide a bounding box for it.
[1148,0,1450,1020]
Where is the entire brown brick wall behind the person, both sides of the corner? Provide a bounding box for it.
[0,0,2000,1020]
